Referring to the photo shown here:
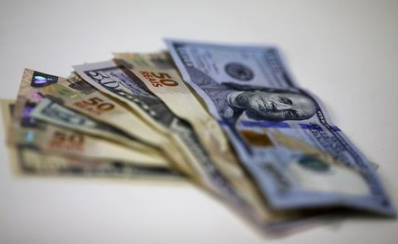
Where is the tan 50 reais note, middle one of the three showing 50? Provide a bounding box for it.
[47,73,190,175]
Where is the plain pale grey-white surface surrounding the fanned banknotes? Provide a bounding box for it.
[0,0,398,244]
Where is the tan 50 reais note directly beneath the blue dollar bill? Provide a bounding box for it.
[114,53,374,231]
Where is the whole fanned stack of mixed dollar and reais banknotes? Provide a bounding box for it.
[3,39,396,232]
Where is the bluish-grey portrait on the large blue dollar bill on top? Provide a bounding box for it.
[183,67,317,124]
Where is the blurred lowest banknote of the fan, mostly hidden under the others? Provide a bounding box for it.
[0,99,185,181]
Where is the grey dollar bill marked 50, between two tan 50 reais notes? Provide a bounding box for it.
[74,61,276,227]
